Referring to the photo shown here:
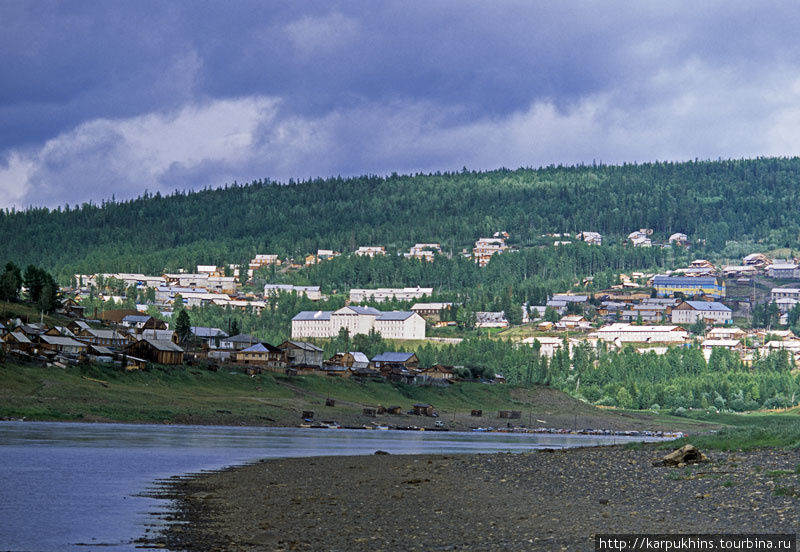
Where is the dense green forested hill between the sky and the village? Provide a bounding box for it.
[0,158,800,276]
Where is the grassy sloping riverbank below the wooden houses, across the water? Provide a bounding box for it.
[0,363,719,433]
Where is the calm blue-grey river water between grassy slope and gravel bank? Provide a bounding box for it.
[0,422,668,552]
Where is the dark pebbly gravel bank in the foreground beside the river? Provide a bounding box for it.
[156,446,800,551]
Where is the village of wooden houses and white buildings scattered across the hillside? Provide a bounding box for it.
[0,229,800,384]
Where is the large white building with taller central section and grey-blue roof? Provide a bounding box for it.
[292,307,425,339]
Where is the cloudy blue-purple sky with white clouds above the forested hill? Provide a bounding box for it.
[0,0,800,209]
